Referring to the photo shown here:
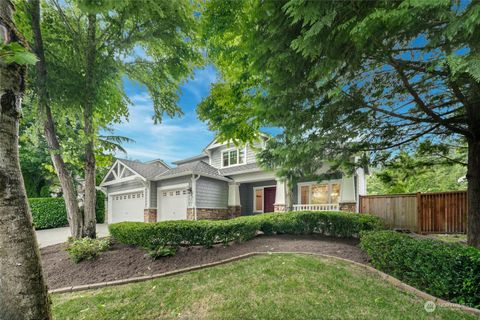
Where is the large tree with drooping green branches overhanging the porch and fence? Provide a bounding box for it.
[199,0,480,247]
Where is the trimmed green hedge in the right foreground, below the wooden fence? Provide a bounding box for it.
[361,231,480,308]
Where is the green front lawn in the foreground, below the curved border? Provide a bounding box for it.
[52,254,475,320]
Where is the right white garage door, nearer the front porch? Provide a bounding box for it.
[157,188,188,221]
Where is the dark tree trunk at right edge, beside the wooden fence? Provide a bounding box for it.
[467,138,480,248]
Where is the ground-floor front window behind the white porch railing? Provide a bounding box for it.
[298,182,341,204]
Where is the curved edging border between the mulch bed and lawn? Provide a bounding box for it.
[49,251,480,316]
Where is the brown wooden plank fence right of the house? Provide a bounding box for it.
[359,191,467,233]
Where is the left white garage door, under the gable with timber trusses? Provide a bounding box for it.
[111,191,145,223]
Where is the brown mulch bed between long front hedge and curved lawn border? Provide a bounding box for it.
[40,235,368,289]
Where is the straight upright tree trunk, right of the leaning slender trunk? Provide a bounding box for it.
[83,14,97,238]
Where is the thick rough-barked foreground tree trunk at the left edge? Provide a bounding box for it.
[0,0,51,320]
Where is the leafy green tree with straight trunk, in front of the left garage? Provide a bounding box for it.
[18,0,200,237]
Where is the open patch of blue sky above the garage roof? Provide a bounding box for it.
[112,65,218,163]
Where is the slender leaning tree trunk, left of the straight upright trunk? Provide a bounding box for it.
[28,0,83,238]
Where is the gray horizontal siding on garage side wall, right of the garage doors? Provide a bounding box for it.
[197,177,228,208]
